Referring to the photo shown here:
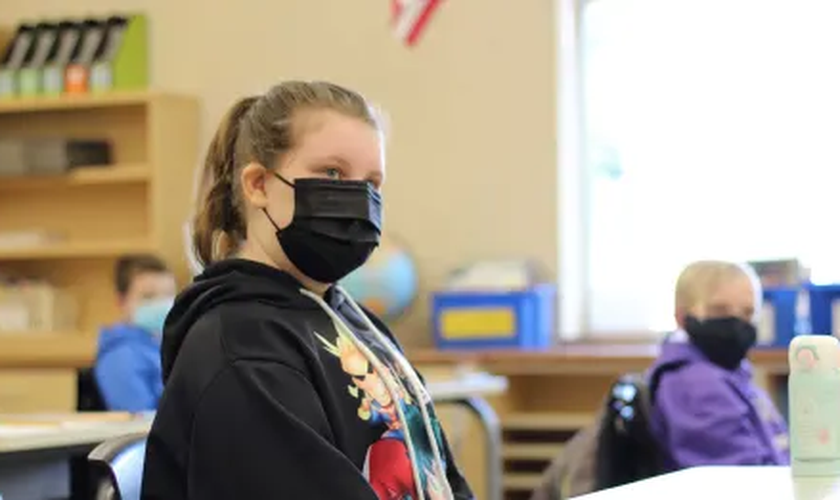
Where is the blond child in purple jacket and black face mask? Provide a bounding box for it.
[650,261,789,469]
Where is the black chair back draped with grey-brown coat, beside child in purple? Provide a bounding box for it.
[531,361,685,500]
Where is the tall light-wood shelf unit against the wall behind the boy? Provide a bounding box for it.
[0,92,199,409]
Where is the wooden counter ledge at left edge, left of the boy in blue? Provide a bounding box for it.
[0,333,96,368]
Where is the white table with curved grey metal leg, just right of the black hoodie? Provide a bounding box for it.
[426,373,507,500]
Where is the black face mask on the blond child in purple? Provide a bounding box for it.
[685,316,758,370]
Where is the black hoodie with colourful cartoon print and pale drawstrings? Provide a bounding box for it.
[142,260,473,500]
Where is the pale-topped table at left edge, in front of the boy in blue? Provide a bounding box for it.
[0,413,151,500]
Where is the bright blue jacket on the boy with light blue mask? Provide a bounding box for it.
[94,324,163,413]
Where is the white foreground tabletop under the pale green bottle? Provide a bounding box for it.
[573,466,840,500]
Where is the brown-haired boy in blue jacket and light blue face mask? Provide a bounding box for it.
[94,255,176,412]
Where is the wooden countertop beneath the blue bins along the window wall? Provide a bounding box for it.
[408,342,788,375]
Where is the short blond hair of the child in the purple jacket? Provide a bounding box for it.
[674,260,762,317]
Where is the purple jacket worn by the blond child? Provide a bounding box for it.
[651,341,790,470]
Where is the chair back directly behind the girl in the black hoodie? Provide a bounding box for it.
[88,432,147,500]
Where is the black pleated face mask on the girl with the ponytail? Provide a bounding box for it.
[263,172,382,283]
